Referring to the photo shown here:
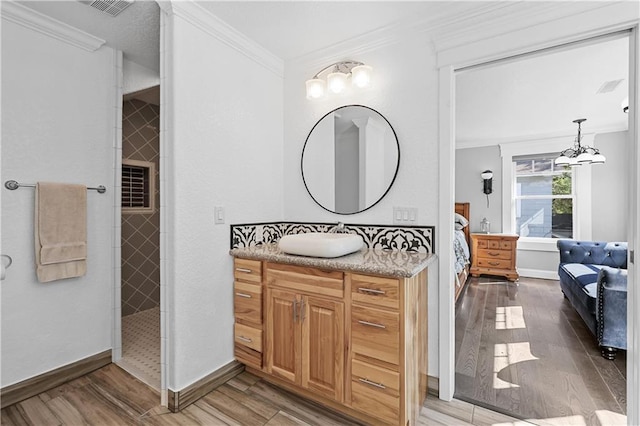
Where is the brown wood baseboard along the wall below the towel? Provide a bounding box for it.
[0,349,111,408]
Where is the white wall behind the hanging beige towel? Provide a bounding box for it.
[0,16,116,387]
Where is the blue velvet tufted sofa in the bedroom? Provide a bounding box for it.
[558,240,627,359]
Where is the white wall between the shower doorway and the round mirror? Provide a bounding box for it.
[168,10,282,390]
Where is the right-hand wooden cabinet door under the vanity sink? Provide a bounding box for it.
[300,296,345,402]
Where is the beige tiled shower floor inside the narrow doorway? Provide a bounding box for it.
[118,307,161,390]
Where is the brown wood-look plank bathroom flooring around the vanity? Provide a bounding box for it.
[0,364,529,426]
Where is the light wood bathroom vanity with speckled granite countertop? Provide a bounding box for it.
[231,244,435,425]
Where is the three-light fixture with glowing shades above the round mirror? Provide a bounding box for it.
[305,61,373,99]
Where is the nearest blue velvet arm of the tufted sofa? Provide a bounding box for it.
[596,266,627,349]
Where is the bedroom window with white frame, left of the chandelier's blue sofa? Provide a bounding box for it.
[512,154,576,238]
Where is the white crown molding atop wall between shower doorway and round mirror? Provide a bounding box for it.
[168,0,284,77]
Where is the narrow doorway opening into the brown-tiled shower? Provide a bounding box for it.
[118,86,161,391]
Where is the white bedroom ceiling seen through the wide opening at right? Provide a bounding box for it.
[456,36,629,146]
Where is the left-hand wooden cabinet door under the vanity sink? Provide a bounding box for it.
[265,289,301,384]
